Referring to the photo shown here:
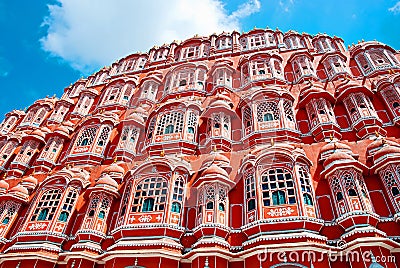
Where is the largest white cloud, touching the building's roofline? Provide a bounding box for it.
[40,0,261,74]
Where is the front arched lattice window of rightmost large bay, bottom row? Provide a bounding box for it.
[261,168,296,206]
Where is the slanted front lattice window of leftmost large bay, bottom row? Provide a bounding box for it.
[31,189,61,221]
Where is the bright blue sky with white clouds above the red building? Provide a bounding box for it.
[0,0,400,120]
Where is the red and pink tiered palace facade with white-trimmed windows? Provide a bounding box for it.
[0,29,400,268]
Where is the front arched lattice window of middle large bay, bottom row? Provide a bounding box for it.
[132,177,168,212]
